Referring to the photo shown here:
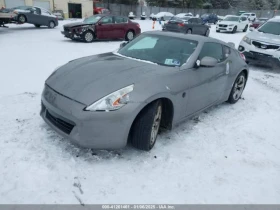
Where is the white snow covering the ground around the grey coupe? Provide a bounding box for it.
[0,20,280,204]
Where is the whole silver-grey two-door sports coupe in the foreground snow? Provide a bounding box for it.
[41,31,249,151]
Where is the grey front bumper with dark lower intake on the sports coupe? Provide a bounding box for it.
[40,86,137,149]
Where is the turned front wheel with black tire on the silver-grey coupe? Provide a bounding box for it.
[130,101,162,151]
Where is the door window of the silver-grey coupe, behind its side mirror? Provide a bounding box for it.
[198,42,224,62]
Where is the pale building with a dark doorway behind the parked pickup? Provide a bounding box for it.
[0,0,93,18]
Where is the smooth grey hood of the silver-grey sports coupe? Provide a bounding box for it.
[46,53,172,105]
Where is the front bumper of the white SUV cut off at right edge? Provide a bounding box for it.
[238,41,280,67]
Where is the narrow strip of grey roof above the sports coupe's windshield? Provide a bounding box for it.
[142,31,228,45]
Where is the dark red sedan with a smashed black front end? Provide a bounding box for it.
[61,14,141,42]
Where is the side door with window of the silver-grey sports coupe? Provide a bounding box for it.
[186,42,227,116]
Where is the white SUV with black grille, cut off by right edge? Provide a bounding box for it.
[238,18,280,68]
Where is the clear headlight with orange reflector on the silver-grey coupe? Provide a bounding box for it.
[85,85,134,111]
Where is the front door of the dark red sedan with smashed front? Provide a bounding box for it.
[96,16,115,39]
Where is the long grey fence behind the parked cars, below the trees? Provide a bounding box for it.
[109,4,280,18]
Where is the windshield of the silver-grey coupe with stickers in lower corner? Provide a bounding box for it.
[118,34,198,67]
